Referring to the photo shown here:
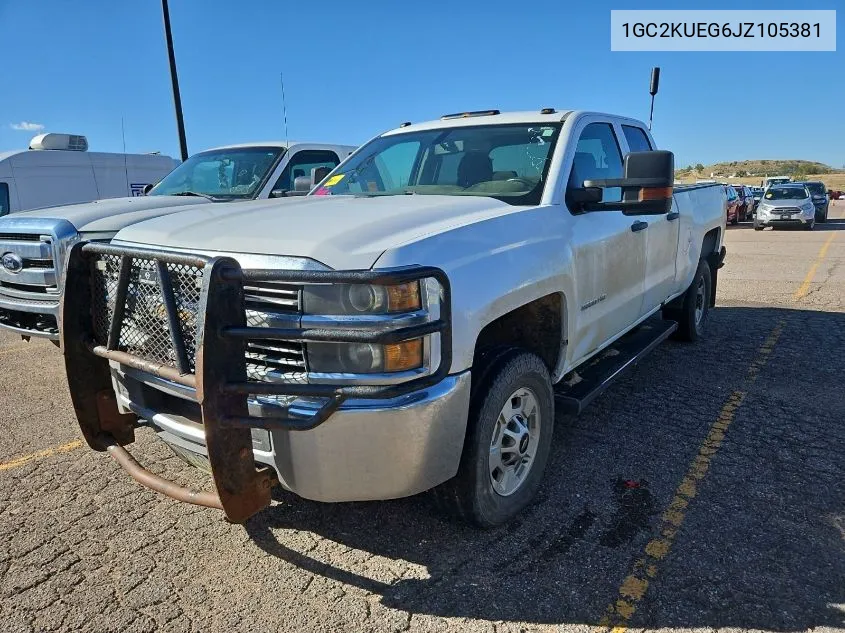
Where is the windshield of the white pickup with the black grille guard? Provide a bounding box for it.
[312,124,560,205]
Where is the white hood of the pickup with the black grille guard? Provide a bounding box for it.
[115,195,525,269]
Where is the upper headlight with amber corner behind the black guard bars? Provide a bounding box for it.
[302,281,422,315]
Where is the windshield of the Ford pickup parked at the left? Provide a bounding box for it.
[147,147,285,200]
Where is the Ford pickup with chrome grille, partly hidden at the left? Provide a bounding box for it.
[0,142,354,341]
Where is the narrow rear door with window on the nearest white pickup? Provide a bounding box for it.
[621,123,680,316]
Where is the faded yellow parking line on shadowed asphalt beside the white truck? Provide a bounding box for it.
[598,321,784,633]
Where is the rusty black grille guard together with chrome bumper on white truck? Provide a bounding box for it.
[61,243,454,523]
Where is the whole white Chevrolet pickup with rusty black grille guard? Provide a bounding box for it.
[62,109,725,527]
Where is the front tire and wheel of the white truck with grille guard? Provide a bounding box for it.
[432,347,554,528]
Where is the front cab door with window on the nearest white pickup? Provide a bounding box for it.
[566,117,647,363]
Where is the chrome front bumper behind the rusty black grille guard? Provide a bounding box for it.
[111,362,470,502]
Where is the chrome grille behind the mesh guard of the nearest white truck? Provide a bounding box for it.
[92,254,305,382]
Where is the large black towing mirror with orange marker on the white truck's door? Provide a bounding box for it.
[583,150,675,215]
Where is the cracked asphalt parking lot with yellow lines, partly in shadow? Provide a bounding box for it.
[0,202,845,633]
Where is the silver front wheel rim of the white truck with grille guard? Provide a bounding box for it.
[487,387,541,497]
